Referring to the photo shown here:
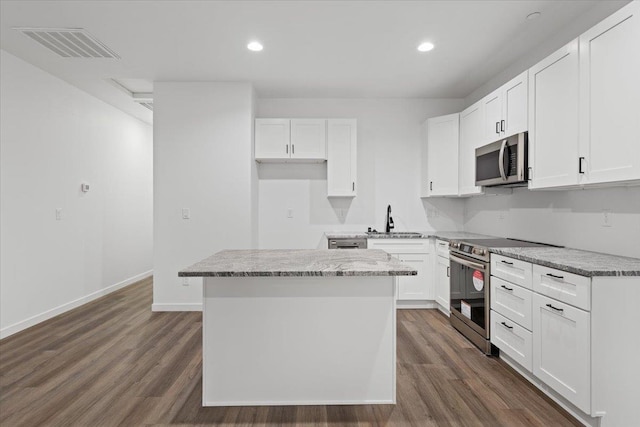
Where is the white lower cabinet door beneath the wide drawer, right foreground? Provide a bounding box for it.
[533,293,591,414]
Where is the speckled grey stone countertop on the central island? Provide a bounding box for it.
[178,249,418,277]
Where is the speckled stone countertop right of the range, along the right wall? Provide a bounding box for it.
[489,248,640,277]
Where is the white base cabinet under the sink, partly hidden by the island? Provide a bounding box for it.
[367,239,435,301]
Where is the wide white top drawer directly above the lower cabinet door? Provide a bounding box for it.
[533,265,591,311]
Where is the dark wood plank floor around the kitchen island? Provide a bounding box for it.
[0,279,579,427]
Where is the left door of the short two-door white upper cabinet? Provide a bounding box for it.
[255,119,291,159]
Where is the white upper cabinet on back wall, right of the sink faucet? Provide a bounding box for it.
[423,113,460,197]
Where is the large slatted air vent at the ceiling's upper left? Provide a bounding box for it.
[14,28,120,59]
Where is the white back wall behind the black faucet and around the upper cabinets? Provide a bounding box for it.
[256,99,463,248]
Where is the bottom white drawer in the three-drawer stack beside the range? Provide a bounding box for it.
[491,310,533,372]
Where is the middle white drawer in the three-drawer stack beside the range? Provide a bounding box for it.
[491,277,533,330]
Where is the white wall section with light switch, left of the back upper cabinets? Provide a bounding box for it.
[153,82,257,311]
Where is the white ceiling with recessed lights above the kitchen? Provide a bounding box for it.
[0,0,626,122]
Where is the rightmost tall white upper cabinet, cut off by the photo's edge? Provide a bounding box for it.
[580,1,640,184]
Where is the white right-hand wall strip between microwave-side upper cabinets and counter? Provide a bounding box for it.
[465,187,640,258]
